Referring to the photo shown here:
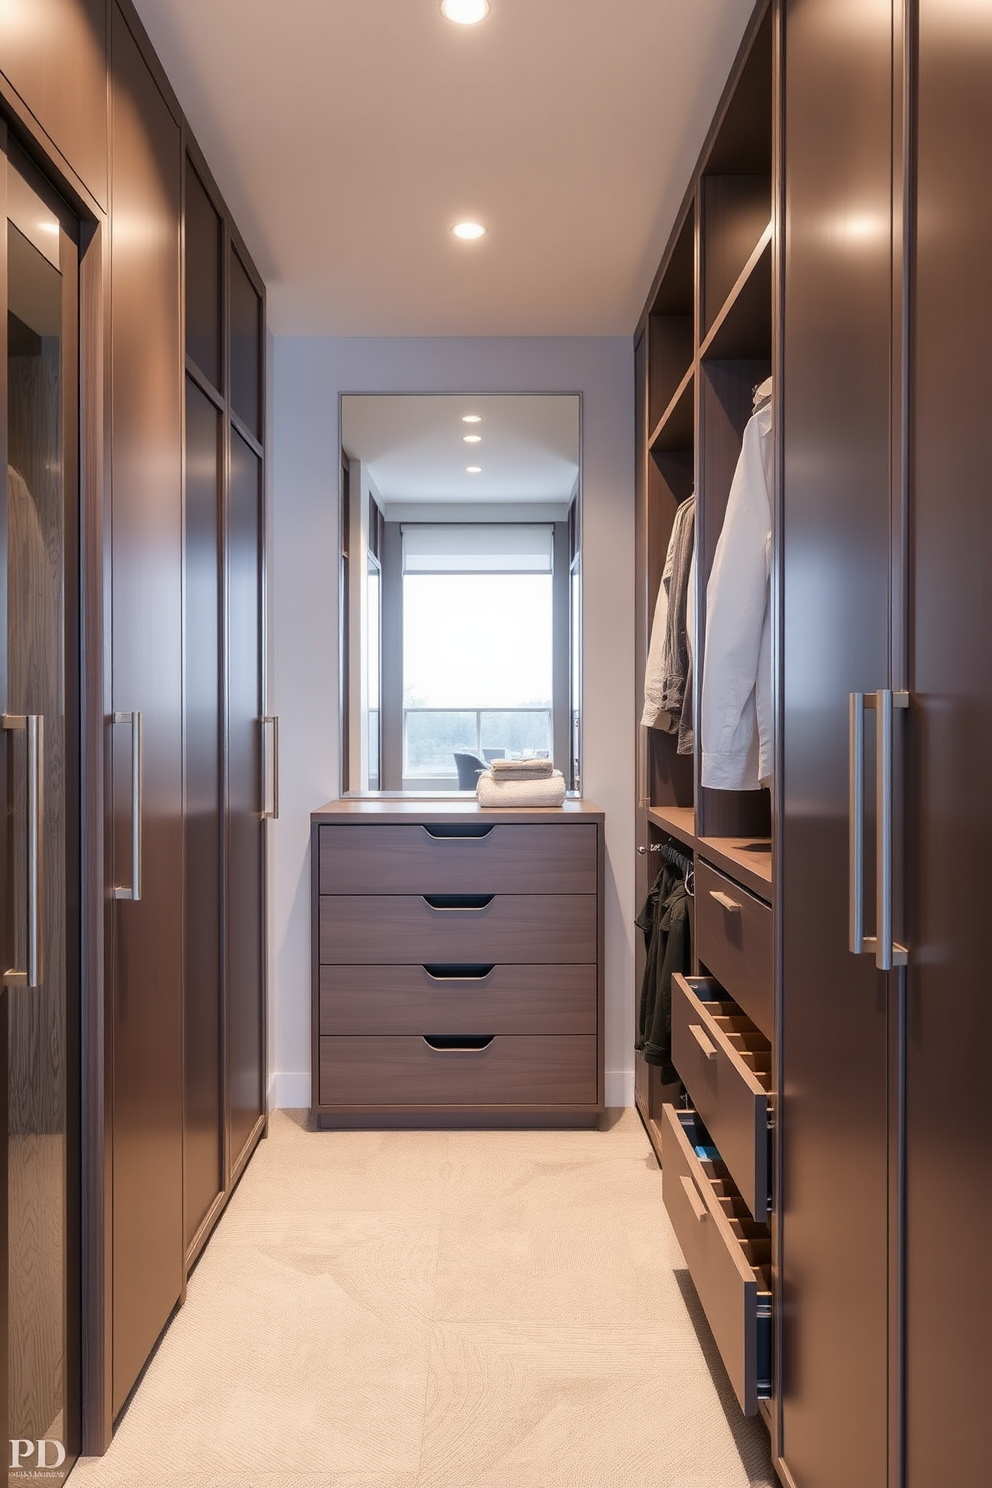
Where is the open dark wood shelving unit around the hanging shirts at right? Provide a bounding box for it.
[635,6,778,1172]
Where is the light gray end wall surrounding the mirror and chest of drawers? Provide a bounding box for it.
[269,336,635,1106]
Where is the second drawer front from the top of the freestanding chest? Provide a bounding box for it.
[320,894,596,966]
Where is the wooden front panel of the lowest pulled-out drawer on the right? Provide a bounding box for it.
[662,1106,770,1415]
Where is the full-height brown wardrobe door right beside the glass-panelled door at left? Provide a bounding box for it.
[112,6,183,1415]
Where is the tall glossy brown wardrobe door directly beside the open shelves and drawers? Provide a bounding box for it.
[778,0,892,1488]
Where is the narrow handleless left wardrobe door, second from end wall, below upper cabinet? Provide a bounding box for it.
[183,378,225,1250]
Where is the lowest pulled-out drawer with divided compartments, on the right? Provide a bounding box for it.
[662,1106,772,1415]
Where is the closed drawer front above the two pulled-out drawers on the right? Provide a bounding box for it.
[696,862,772,1039]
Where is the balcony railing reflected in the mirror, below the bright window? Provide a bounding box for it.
[403,705,555,780]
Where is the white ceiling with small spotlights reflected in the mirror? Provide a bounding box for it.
[341,394,579,518]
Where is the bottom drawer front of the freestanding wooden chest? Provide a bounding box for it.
[320,1036,596,1109]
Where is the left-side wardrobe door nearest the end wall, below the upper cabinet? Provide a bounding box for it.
[228,430,265,1170]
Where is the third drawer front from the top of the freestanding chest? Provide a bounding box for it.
[320,966,596,1034]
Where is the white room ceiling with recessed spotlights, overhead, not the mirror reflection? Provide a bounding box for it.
[130,0,754,336]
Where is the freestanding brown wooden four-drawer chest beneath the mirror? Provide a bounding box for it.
[311,799,604,1128]
